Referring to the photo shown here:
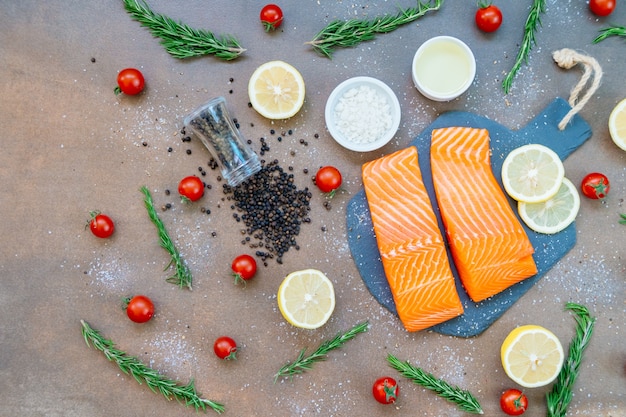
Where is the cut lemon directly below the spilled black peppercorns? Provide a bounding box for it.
[278,269,335,329]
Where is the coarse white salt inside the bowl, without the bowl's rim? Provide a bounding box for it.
[335,85,393,143]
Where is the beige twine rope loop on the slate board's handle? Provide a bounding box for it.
[552,48,602,130]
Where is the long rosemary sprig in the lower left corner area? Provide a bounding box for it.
[80,320,224,414]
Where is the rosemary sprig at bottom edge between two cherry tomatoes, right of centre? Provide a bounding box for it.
[387,354,483,414]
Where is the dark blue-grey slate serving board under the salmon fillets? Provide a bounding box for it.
[346,98,591,337]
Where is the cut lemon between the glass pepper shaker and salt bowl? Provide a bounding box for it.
[248,61,304,119]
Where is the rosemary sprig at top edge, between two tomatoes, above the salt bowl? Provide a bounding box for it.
[306,0,443,58]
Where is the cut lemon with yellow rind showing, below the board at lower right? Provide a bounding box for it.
[500,324,565,388]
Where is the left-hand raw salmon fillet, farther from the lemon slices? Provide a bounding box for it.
[362,146,463,331]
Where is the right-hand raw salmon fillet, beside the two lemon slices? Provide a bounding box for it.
[430,127,537,302]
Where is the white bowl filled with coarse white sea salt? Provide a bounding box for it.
[325,77,400,152]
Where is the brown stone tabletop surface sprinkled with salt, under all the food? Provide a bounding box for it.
[0,0,626,416]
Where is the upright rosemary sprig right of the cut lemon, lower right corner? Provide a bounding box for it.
[546,303,596,417]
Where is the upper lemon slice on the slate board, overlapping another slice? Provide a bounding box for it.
[502,144,565,203]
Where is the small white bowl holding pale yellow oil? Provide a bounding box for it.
[411,36,476,101]
